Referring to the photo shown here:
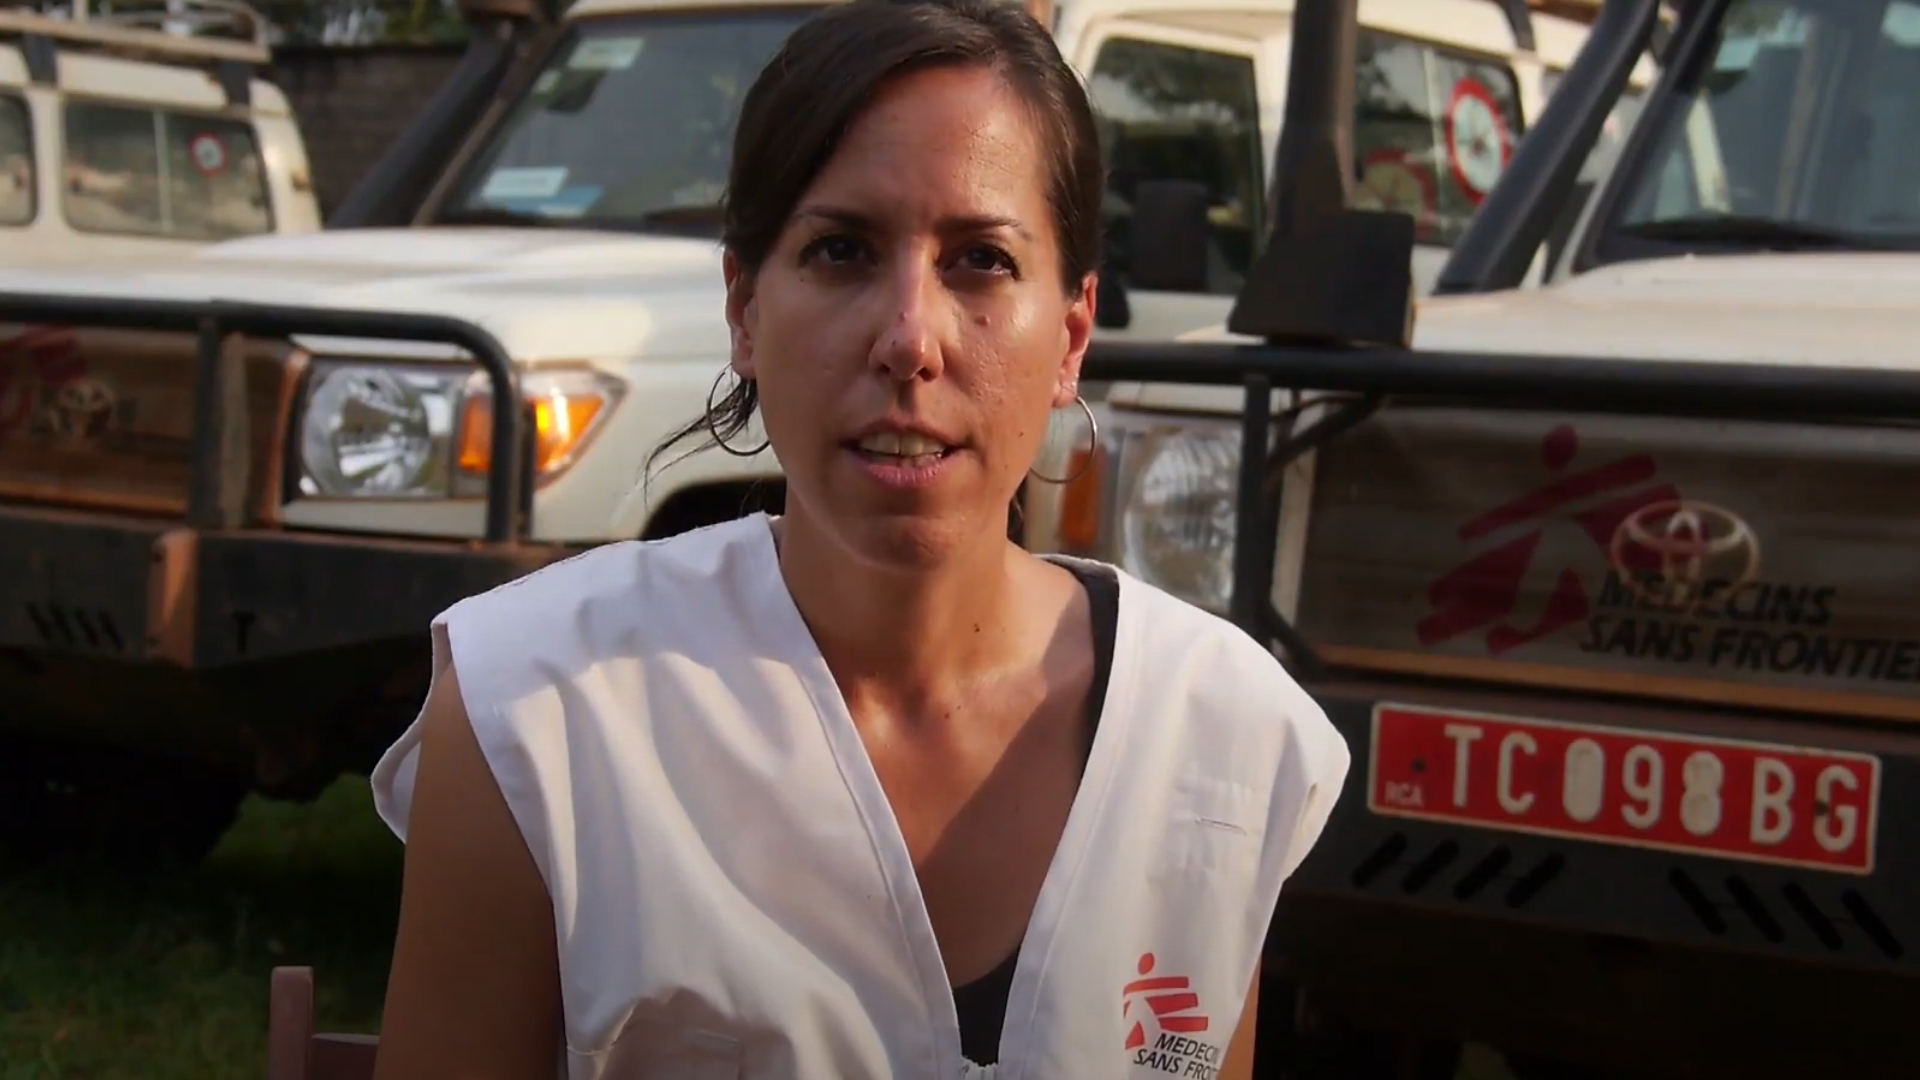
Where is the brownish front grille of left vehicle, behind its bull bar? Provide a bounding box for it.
[0,327,298,519]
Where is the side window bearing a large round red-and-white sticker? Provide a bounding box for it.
[1354,29,1524,246]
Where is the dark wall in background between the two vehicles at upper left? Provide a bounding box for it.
[271,44,461,215]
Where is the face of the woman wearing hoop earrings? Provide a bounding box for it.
[726,69,1092,569]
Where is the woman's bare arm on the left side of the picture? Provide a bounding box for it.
[374,663,563,1080]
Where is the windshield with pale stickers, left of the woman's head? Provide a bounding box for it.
[438,8,814,229]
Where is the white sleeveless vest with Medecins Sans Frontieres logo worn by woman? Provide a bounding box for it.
[372,515,1350,1080]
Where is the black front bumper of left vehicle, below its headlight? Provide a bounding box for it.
[0,505,574,669]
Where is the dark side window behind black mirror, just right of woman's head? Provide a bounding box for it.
[1089,37,1265,296]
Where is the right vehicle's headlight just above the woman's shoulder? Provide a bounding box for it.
[1114,425,1240,613]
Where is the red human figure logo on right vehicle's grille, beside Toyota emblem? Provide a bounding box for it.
[1413,425,1680,655]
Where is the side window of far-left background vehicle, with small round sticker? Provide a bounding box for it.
[61,102,273,240]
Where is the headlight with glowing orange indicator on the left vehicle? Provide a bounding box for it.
[298,361,622,498]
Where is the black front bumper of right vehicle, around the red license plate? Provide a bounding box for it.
[1288,682,1920,978]
